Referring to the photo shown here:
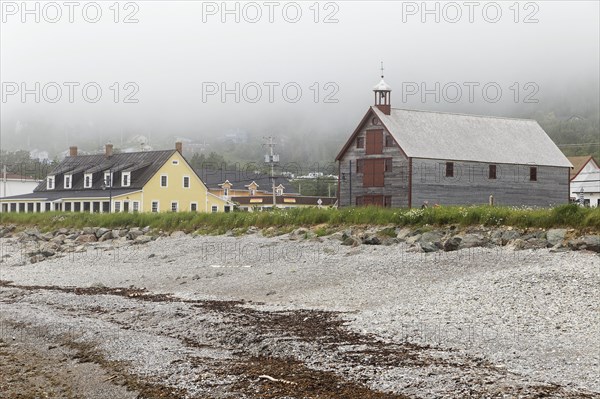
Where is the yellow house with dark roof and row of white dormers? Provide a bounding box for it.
[0,143,233,212]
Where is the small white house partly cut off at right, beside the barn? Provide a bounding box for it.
[569,156,600,207]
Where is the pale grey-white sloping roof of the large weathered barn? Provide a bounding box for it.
[371,107,572,168]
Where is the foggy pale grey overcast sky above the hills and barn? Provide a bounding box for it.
[0,1,600,149]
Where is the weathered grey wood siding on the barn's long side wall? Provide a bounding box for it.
[412,158,569,207]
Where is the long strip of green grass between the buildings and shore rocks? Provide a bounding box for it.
[0,205,600,234]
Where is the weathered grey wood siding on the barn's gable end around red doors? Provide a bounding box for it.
[339,112,408,207]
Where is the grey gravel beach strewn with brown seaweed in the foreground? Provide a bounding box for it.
[0,234,600,398]
